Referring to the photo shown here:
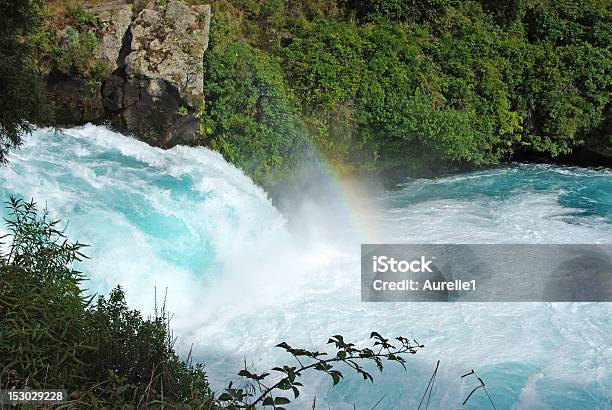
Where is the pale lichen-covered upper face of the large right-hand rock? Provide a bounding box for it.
[125,0,210,105]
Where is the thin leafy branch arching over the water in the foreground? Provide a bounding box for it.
[218,332,424,409]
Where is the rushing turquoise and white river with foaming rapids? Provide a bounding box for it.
[0,126,612,409]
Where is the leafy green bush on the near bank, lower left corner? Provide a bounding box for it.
[0,198,212,407]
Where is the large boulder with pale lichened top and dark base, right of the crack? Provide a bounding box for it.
[102,0,210,148]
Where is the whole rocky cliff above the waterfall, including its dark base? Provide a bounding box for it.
[47,0,211,148]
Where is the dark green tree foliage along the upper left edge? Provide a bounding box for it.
[0,0,51,163]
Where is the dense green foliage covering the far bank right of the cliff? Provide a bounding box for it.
[205,0,612,178]
